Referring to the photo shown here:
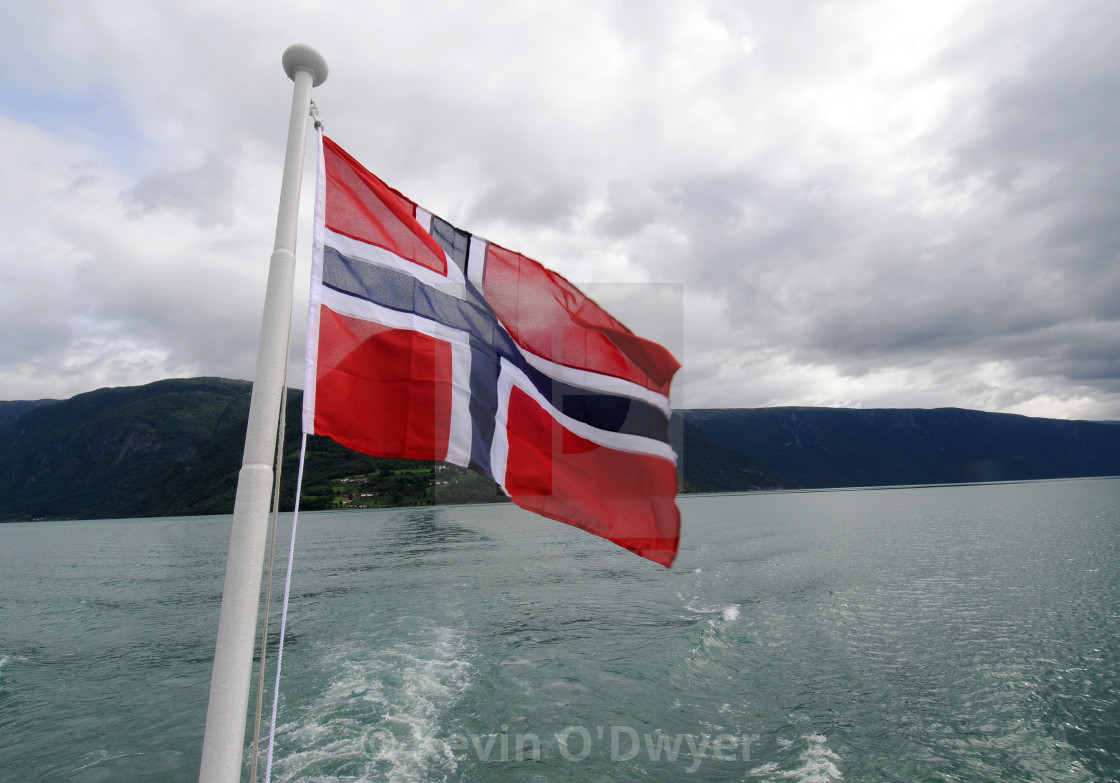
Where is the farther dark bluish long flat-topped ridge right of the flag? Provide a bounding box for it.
[683,408,1120,487]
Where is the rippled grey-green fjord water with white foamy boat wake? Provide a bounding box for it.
[0,479,1120,783]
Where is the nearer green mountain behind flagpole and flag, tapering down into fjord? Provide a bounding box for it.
[0,377,793,521]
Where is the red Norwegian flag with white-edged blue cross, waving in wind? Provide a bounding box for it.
[304,137,680,566]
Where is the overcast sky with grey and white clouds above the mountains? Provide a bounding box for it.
[0,0,1120,419]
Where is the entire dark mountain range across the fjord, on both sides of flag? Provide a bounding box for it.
[0,377,1120,521]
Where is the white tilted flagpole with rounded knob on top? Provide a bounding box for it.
[198,44,327,783]
